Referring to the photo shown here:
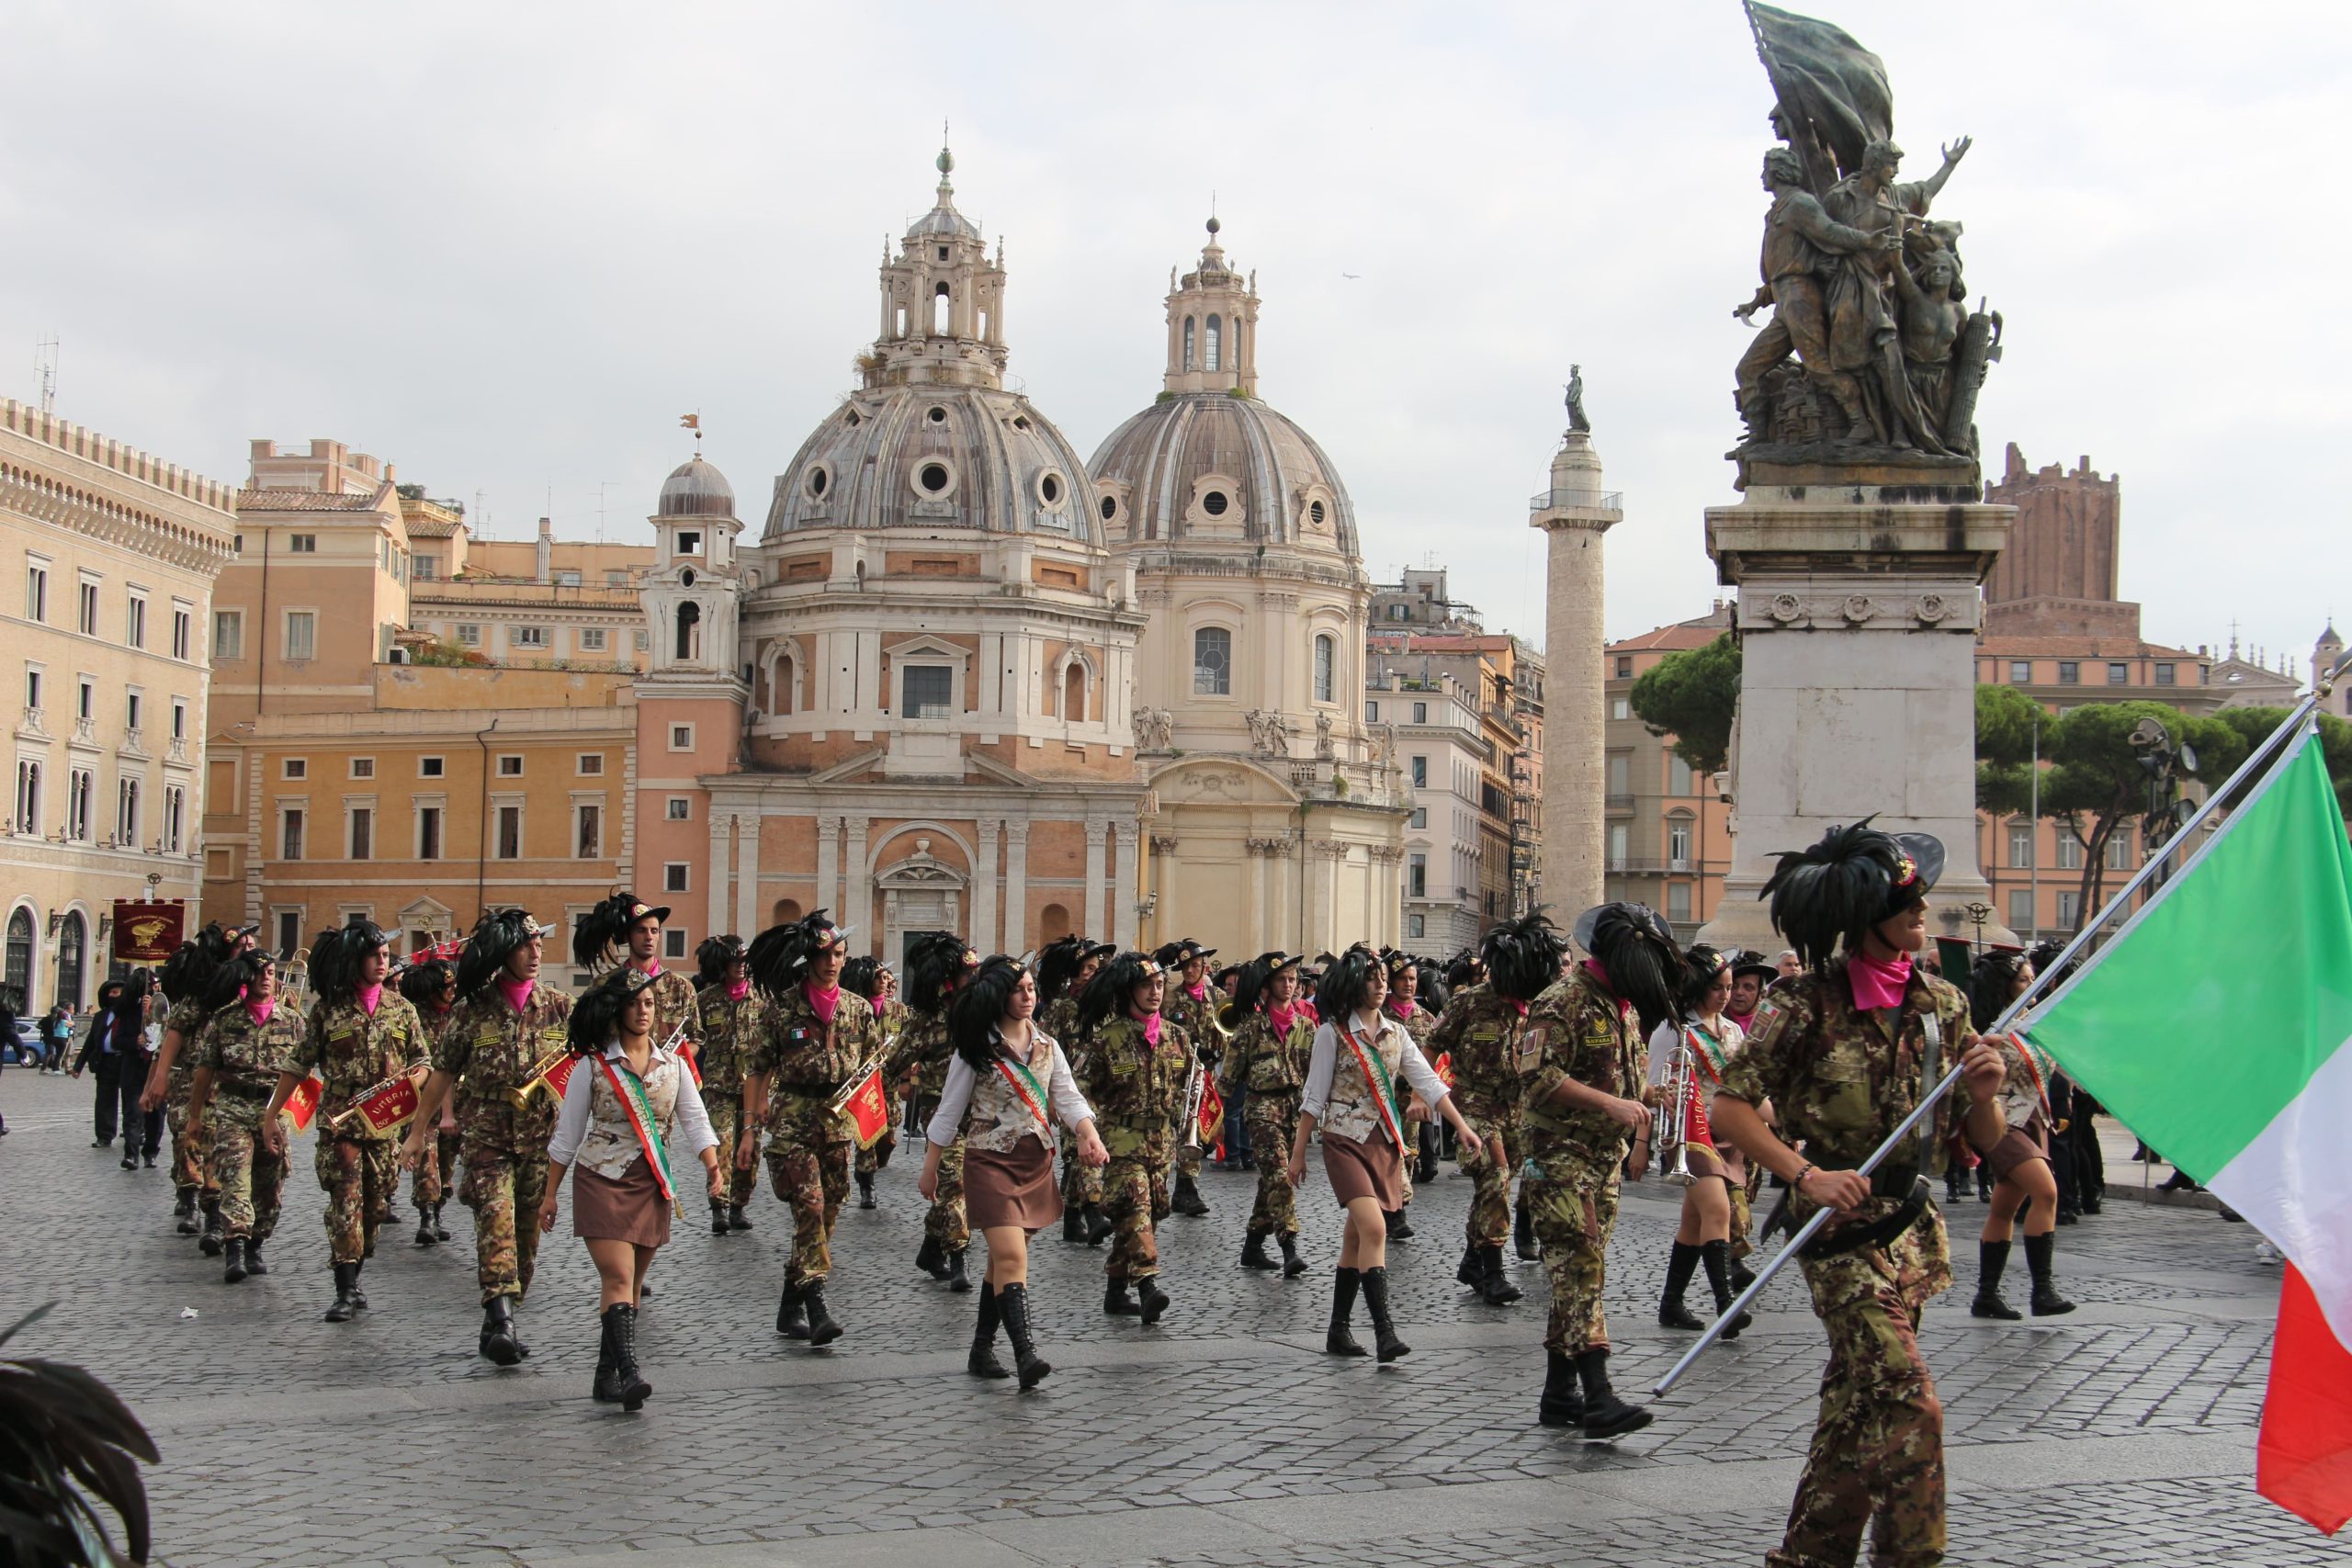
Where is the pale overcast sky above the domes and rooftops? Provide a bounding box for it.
[0,0,2352,670]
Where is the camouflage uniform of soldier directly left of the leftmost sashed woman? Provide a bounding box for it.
[433,980,571,1304]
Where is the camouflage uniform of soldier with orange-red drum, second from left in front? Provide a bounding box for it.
[287,987,430,1262]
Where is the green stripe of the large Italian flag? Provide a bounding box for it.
[2028,736,2352,1180]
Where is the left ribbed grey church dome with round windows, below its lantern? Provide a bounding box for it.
[764,386,1103,546]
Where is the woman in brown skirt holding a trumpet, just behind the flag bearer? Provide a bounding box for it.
[1649,947,1755,1340]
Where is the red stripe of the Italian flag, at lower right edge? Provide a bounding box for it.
[2253,1262,2352,1535]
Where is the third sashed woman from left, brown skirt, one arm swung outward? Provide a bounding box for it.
[1268,942,1484,1363]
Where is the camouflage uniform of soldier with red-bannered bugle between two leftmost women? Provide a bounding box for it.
[746,987,875,1288]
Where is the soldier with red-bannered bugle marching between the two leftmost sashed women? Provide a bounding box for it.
[734,909,875,1349]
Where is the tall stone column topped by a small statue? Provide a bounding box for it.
[1529,392,1625,929]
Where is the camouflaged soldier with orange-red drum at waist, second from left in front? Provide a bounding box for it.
[261,917,430,1324]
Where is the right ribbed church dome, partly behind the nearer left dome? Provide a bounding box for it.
[1087,392,1357,559]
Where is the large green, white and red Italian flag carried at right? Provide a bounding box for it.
[2028,733,2352,1535]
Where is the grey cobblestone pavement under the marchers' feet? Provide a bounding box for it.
[0,1069,2345,1568]
